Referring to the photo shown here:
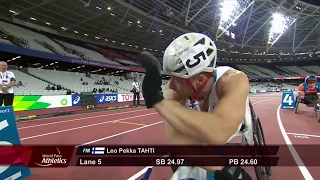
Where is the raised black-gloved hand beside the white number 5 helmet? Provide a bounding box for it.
[138,52,163,108]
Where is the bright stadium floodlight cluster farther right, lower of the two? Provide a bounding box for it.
[268,13,296,48]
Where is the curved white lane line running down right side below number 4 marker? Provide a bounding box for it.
[277,104,313,180]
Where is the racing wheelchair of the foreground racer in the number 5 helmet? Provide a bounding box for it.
[141,100,272,180]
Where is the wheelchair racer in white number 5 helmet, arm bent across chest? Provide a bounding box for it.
[139,33,251,180]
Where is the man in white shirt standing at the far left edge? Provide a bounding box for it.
[0,61,16,106]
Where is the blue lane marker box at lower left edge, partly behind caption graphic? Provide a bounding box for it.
[0,106,31,180]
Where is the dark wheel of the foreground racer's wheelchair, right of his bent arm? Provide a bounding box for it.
[249,102,272,180]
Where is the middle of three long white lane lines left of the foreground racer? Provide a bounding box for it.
[20,113,158,141]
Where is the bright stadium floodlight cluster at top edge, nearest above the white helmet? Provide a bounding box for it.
[216,0,254,39]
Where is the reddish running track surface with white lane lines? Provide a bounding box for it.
[18,93,320,180]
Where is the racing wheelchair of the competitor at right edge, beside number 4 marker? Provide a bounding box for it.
[294,93,320,122]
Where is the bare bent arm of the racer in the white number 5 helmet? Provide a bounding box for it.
[154,70,250,145]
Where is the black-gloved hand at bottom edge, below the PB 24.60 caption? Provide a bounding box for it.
[214,166,252,180]
